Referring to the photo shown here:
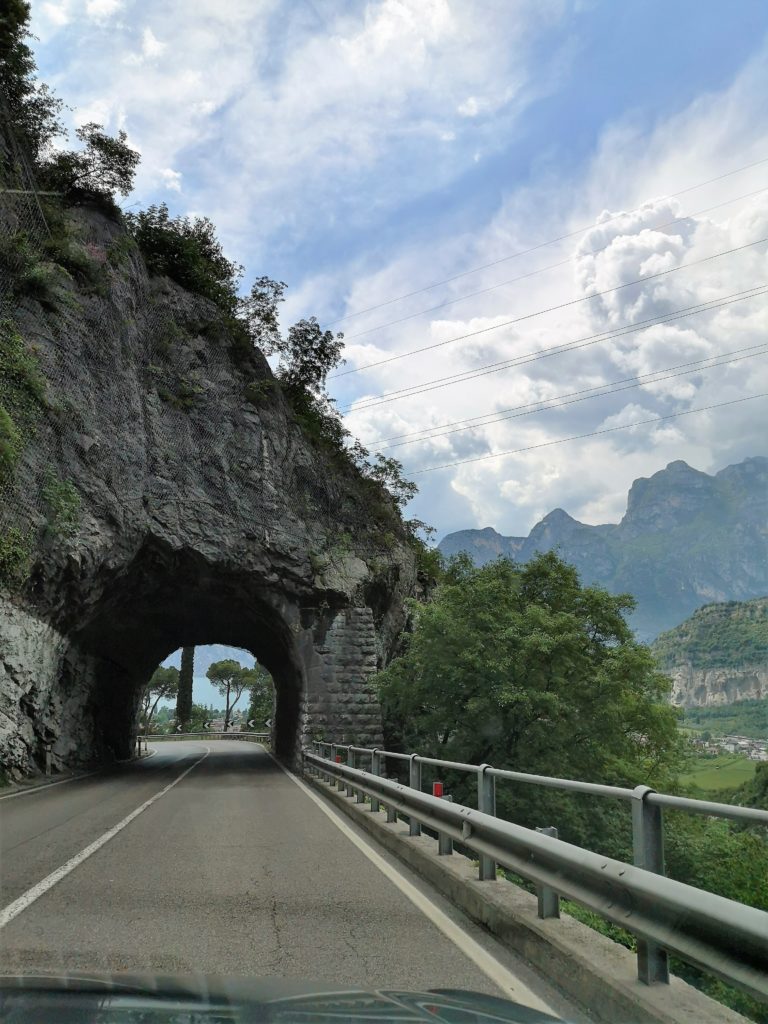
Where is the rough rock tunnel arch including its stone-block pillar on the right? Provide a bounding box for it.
[70,544,387,763]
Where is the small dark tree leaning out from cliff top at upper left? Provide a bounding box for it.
[42,122,141,198]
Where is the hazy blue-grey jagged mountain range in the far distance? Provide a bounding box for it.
[439,457,768,640]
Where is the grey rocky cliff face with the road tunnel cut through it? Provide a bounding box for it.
[0,203,415,775]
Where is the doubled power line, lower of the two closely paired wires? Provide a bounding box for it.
[374,342,768,452]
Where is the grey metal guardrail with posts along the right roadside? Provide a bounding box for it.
[304,742,768,1001]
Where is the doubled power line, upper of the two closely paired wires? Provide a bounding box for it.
[342,285,768,413]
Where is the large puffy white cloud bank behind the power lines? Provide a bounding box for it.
[335,44,768,535]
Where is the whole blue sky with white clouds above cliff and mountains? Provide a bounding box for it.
[32,0,768,539]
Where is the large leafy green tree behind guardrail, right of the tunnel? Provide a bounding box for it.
[379,553,681,854]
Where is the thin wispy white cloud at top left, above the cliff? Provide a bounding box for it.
[28,0,562,272]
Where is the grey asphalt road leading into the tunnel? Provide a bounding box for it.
[0,740,577,1019]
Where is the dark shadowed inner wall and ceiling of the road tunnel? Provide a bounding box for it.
[72,545,306,763]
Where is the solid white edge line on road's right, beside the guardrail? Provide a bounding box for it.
[269,754,557,1017]
